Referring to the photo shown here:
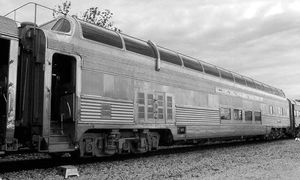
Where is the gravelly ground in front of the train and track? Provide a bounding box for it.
[0,140,300,180]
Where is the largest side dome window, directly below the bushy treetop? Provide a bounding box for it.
[80,23,122,48]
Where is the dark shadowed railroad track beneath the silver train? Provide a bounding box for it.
[0,140,278,173]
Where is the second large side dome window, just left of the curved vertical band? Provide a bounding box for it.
[123,36,155,57]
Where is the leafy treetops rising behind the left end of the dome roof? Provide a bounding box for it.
[53,1,121,32]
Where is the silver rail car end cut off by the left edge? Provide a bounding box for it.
[0,16,19,151]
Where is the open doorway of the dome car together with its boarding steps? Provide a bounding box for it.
[44,52,80,153]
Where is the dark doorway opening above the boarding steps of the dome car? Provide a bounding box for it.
[50,53,76,138]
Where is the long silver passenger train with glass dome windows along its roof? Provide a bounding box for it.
[0,16,294,156]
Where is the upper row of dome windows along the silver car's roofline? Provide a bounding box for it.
[78,19,285,97]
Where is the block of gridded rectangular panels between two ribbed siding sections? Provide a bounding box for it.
[136,92,174,120]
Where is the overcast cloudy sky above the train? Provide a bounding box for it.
[0,0,300,99]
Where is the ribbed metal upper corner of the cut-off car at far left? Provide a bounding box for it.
[0,16,18,37]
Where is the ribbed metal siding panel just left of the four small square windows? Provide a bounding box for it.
[176,106,220,125]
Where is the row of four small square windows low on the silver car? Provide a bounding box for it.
[220,107,261,121]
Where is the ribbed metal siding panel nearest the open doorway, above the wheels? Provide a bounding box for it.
[80,95,134,124]
